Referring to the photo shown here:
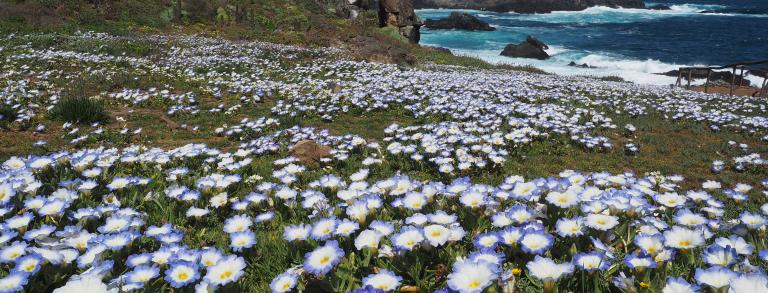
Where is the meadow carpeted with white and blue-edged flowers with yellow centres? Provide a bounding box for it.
[0,32,768,293]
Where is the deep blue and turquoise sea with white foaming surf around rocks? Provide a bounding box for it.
[417,0,768,85]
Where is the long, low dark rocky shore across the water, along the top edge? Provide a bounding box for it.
[413,0,645,13]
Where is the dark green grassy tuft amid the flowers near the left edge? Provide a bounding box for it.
[52,97,108,123]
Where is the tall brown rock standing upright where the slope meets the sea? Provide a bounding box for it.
[379,0,423,44]
